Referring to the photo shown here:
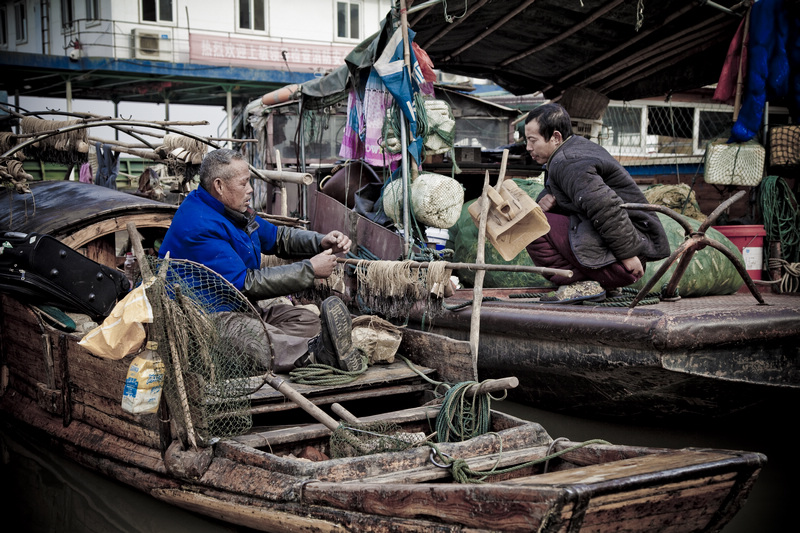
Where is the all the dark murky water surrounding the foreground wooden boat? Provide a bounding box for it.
[0,402,788,533]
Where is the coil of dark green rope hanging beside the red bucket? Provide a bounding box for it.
[760,176,800,263]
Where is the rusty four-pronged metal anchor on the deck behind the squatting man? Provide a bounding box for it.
[622,191,766,308]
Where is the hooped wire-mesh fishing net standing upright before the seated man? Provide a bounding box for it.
[148,259,272,446]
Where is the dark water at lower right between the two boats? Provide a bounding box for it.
[492,402,800,533]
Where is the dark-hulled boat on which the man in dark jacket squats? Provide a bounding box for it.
[310,185,800,420]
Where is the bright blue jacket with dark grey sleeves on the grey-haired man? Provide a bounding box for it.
[158,187,322,297]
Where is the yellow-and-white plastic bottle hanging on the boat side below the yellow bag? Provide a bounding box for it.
[122,341,164,415]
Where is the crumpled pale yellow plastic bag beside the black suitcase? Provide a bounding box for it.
[78,280,153,360]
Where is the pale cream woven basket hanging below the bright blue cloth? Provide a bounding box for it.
[703,141,766,187]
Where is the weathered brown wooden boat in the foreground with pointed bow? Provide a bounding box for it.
[0,178,766,531]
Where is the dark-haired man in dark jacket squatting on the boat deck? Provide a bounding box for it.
[525,104,670,301]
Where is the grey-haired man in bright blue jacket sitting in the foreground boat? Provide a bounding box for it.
[158,149,361,372]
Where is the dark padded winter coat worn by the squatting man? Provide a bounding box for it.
[539,135,670,268]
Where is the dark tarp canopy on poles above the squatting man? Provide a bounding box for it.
[302,0,746,105]
